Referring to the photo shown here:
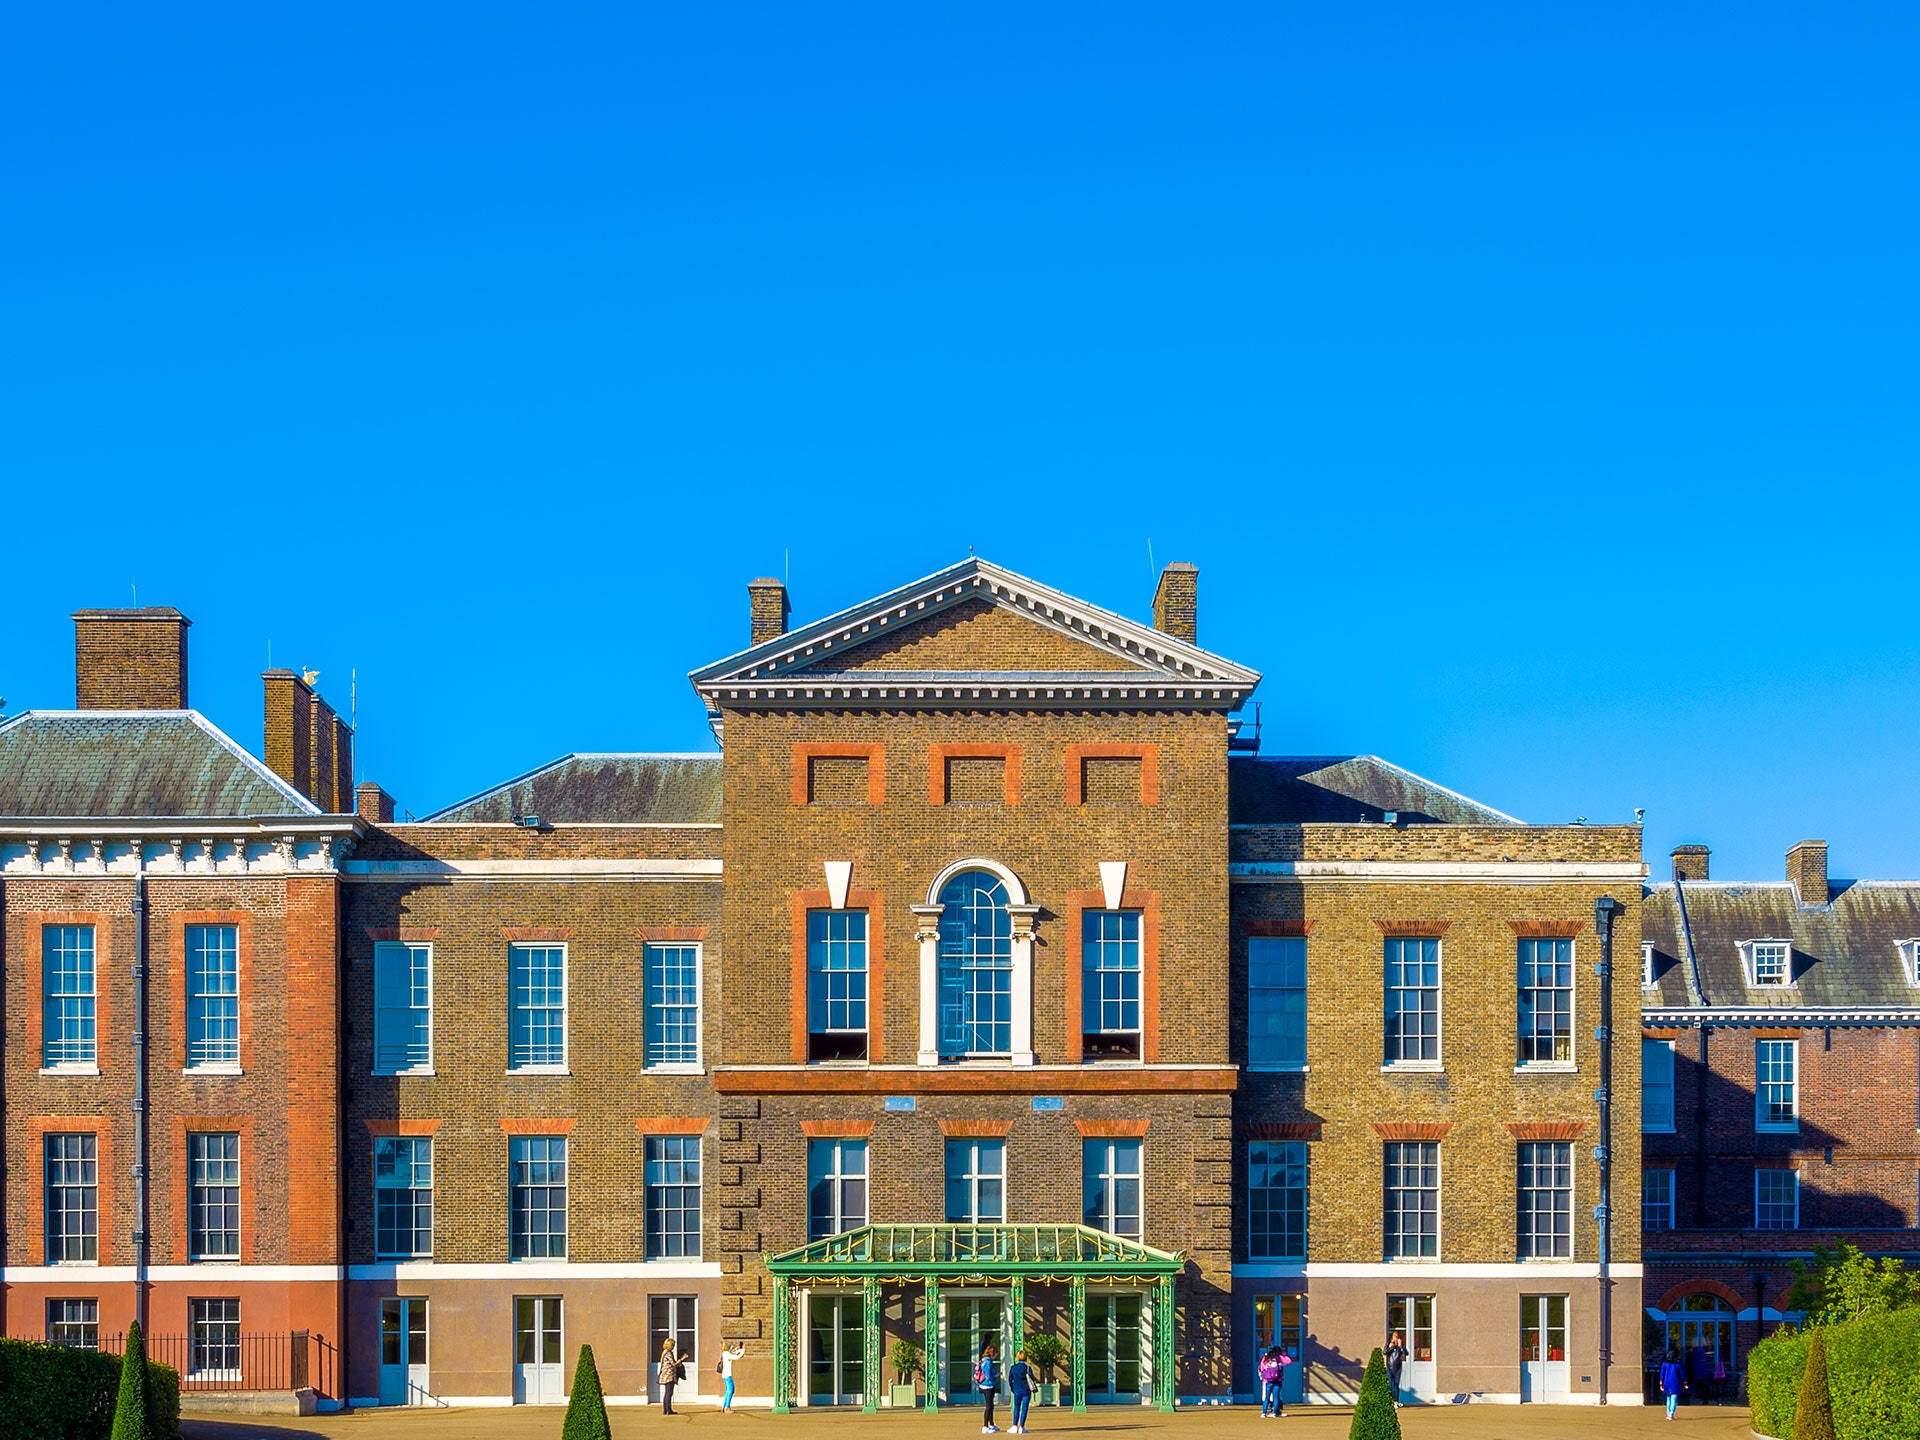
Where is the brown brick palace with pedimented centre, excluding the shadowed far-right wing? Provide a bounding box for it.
[0,559,1681,1407]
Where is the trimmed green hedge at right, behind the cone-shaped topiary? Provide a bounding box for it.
[1747,1309,1920,1440]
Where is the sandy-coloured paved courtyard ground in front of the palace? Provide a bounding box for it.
[180,1405,1751,1440]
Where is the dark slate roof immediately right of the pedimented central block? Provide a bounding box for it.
[1227,755,1523,826]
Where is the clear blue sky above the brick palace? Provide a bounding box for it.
[0,4,1920,877]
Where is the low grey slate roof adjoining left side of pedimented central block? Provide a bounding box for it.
[426,755,720,826]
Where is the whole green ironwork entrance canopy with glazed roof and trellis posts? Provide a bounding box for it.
[762,1225,1187,1415]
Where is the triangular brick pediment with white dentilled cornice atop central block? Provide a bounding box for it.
[691,557,1260,708]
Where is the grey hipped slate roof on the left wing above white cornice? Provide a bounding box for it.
[0,710,321,820]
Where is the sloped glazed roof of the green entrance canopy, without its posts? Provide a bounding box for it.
[766,1225,1187,1281]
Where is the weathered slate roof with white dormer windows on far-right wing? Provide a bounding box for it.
[1642,881,1920,1010]
